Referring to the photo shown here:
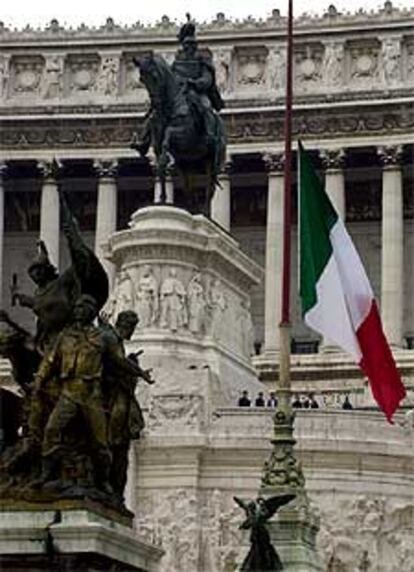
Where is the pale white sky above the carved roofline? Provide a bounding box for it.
[0,0,414,28]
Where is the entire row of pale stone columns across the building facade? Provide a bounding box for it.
[0,146,403,355]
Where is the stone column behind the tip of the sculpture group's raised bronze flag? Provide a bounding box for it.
[38,160,61,268]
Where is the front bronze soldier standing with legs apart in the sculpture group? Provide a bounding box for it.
[35,294,146,495]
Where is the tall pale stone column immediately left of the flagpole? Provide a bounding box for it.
[263,154,284,357]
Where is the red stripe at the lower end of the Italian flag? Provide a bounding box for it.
[356,300,405,423]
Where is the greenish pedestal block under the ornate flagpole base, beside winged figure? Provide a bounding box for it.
[267,507,323,572]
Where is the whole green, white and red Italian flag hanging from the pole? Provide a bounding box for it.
[299,143,405,422]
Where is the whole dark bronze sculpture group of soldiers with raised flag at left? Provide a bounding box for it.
[0,187,153,506]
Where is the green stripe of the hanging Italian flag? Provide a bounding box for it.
[299,142,338,314]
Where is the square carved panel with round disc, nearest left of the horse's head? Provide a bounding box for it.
[65,53,101,96]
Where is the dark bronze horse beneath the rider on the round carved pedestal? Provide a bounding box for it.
[134,55,226,216]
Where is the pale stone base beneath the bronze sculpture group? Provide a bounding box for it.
[0,503,163,572]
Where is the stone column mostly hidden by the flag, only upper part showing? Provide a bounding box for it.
[320,149,346,220]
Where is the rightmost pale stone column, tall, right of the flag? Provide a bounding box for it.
[378,145,404,347]
